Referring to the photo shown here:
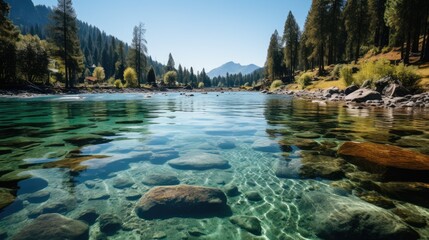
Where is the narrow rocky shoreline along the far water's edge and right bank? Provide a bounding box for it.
[0,87,429,109]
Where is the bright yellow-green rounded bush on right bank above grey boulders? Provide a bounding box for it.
[355,59,394,85]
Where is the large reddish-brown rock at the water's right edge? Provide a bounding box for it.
[338,142,429,181]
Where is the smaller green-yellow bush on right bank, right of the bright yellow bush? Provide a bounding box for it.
[393,63,421,92]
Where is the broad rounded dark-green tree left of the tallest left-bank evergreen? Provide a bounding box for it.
[16,35,49,84]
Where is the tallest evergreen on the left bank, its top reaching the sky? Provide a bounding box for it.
[49,0,83,88]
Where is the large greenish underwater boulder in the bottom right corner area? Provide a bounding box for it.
[300,192,419,240]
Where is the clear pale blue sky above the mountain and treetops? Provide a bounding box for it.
[33,0,311,71]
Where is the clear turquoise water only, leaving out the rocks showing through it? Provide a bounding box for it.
[0,93,429,239]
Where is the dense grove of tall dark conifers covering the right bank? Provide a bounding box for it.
[265,0,429,82]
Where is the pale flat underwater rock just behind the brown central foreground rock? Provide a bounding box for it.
[168,153,231,170]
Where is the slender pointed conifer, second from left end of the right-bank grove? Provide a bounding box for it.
[283,11,300,81]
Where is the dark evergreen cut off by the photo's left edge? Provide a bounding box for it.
[0,0,19,84]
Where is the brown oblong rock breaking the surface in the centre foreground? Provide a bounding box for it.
[135,185,230,219]
